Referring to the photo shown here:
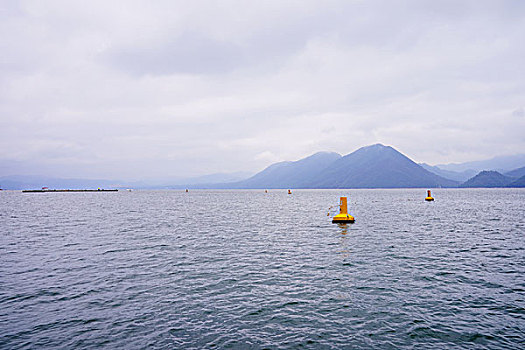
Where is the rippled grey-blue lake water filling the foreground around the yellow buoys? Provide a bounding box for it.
[0,189,525,349]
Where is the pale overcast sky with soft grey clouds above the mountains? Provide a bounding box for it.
[0,0,525,179]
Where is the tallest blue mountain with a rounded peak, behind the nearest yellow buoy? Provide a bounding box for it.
[308,144,458,188]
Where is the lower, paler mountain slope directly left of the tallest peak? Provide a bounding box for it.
[224,152,341,188]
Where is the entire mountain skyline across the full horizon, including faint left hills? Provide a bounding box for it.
[4,144,525,189]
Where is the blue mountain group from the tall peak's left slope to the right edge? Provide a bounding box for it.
[224,144,525,188]
